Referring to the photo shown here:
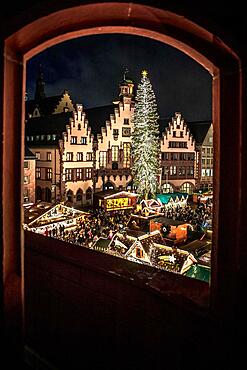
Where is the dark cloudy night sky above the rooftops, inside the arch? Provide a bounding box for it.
[26,34,212,121]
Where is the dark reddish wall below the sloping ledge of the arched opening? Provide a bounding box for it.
[25,232,229,370]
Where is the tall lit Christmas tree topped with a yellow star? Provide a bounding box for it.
[132,71,160,199]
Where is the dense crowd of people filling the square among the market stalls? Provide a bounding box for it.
[29,198,212,248]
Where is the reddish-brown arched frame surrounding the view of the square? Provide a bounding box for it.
[3,3,242,350]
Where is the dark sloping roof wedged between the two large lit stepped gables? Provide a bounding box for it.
[84,104,115,136]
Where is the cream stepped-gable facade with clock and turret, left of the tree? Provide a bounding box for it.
[96,79,134,190]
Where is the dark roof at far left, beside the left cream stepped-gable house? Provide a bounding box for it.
[25,112,73,135]
